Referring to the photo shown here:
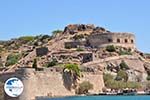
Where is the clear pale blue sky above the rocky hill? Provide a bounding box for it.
[0,0,150,53]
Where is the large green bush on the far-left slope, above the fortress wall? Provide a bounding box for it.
[5,54,21,66]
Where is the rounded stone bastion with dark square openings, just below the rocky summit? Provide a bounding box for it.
[88,32,135,49]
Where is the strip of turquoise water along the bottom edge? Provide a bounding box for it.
[37,96,150,100]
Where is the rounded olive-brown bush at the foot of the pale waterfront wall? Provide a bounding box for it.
[76,81,93,94]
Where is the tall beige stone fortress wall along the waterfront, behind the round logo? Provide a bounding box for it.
[0,68,104,100]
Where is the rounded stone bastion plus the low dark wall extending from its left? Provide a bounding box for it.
[65,32,136,49]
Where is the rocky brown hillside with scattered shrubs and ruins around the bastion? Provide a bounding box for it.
[0,24,150,88]
